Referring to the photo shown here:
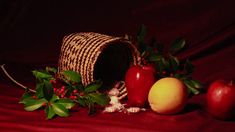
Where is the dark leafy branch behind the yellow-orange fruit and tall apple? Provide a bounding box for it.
[132,25,202,94]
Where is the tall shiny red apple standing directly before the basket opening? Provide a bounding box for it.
[125,65,155,107]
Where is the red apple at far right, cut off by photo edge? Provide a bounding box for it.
[206,80,235,120]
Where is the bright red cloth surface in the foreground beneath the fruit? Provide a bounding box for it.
[0,83,235,132]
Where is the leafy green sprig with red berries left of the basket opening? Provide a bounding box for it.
[19,67,109,119]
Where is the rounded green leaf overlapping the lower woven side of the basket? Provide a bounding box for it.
[63,70,81,83]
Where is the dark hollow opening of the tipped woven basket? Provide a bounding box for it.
[94,42,133,89]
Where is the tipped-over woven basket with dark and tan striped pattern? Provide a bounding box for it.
[58,32,139,86]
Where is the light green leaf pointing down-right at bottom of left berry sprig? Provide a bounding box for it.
[51,103,69,117]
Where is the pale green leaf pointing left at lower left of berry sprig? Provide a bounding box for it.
[24,99,47,111]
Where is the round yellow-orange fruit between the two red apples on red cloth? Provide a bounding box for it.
[148,77,187,114]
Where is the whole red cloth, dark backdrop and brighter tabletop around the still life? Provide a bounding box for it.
[0,0,235,131]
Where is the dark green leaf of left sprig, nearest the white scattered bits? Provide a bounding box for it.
[89,93,110,106]
